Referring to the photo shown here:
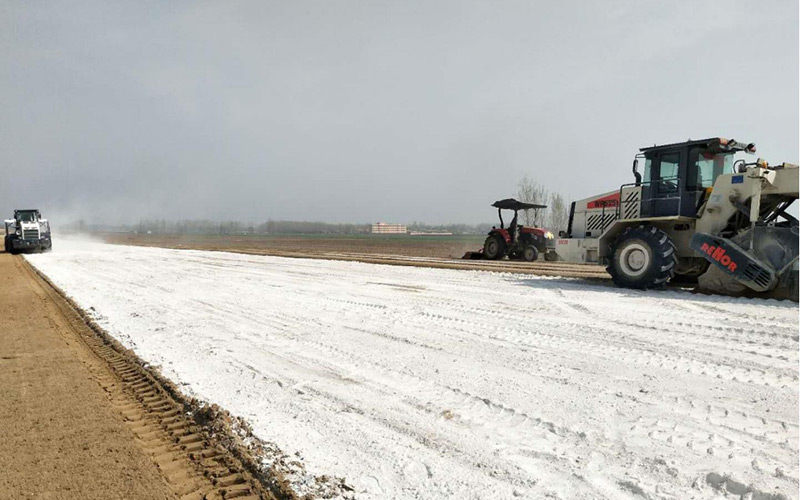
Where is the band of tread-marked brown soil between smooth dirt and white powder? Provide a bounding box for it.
[17,259,296,500]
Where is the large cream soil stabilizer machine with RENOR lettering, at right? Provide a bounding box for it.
[556,138,799,302]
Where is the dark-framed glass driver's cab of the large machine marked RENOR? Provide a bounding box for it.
[634,138,755,217]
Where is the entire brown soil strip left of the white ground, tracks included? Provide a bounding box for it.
[0,254,296,500]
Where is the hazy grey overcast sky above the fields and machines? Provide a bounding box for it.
[0,0,798,223]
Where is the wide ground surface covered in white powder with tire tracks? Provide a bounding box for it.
[28,239,798,500]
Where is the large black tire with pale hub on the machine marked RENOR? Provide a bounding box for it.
[606,224,678,290]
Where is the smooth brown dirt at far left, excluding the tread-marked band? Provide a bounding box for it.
[0,253,173,499]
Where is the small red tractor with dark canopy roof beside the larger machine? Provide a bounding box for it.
[464,198,553,262]
